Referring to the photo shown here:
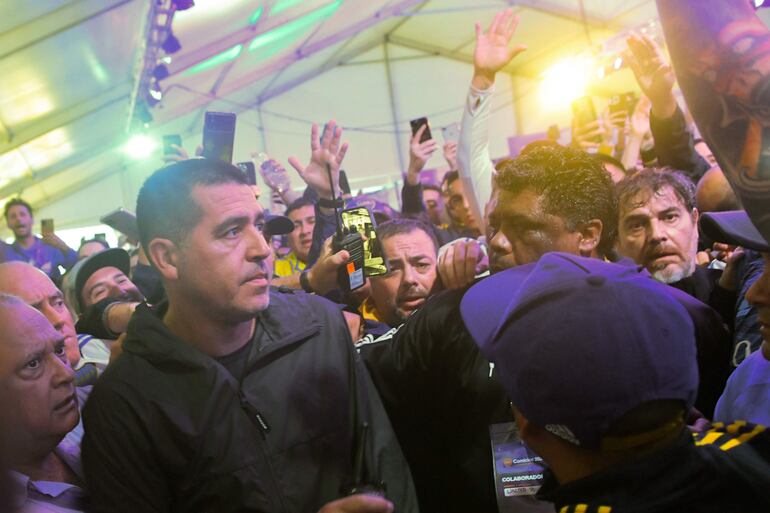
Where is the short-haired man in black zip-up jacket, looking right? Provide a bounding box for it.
[83,159,416,513]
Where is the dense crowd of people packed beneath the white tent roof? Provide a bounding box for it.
[0,1,770,513]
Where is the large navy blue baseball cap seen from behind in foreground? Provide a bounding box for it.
[461,253,698,448]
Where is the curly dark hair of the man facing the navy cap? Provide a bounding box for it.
[496,145,618,255]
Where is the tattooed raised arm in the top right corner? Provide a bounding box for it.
[657,0,770,240]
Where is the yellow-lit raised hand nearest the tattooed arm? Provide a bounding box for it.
[626,34,676,118]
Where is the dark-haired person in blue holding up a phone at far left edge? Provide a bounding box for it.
[4,198,78,283]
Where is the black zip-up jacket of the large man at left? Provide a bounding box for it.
[83,289,417,513]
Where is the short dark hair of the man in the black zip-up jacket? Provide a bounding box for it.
[136,159,248,255]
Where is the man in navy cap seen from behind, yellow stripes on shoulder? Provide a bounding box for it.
[461,253,770,513]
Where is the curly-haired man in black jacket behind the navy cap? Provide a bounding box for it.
[359,142,730,513]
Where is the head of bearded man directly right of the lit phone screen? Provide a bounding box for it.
[361,219,438,327]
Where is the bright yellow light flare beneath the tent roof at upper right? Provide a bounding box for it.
[540,56,596,110]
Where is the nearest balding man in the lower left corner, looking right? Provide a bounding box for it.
[0,293,88,511]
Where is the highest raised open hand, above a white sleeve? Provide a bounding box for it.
[473,9,527,89]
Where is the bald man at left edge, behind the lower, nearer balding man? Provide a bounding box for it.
[0,262,110,378]
